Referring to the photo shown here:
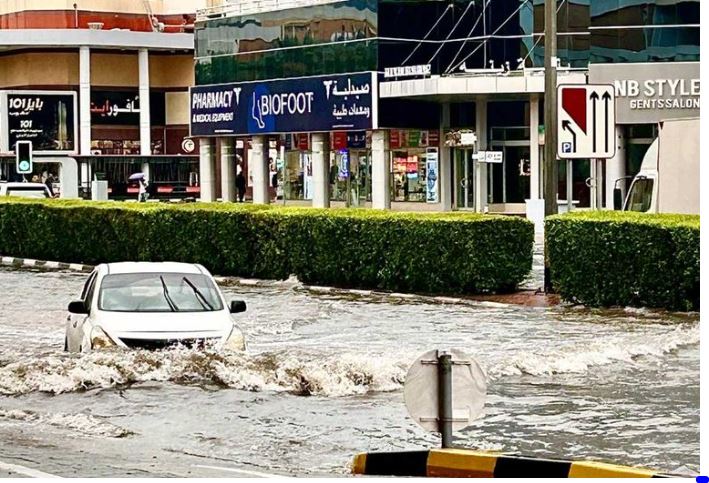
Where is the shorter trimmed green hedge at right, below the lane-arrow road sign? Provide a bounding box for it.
[545,211,699,310]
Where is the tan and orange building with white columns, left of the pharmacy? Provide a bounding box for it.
[0,0,207,199]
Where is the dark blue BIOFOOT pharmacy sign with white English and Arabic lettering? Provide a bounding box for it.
[190,72,377,136]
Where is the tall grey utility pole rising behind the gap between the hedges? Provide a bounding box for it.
[543,0,559,216]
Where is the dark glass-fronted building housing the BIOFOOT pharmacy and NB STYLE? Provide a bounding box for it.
[191,0,699,216]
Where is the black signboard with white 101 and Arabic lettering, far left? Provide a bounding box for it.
[2,91,77,153]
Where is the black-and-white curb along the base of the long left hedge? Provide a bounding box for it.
[0,253,510,308]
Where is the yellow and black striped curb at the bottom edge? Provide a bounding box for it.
[352,449,669,478]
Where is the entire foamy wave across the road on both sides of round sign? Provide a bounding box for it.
[0,324,699,397]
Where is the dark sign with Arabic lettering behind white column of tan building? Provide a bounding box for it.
[90,90,165,126]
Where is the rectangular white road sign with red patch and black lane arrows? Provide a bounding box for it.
[557,85,616,159]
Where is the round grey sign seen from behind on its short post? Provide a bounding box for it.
[404,350,487,448]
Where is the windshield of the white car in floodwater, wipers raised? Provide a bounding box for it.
[98,273,223,312]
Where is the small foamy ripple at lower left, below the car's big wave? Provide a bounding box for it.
[0,408,135,438]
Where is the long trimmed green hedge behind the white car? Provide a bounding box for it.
[0,200,534,293]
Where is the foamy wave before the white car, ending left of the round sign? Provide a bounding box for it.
[0,349,406,397]
